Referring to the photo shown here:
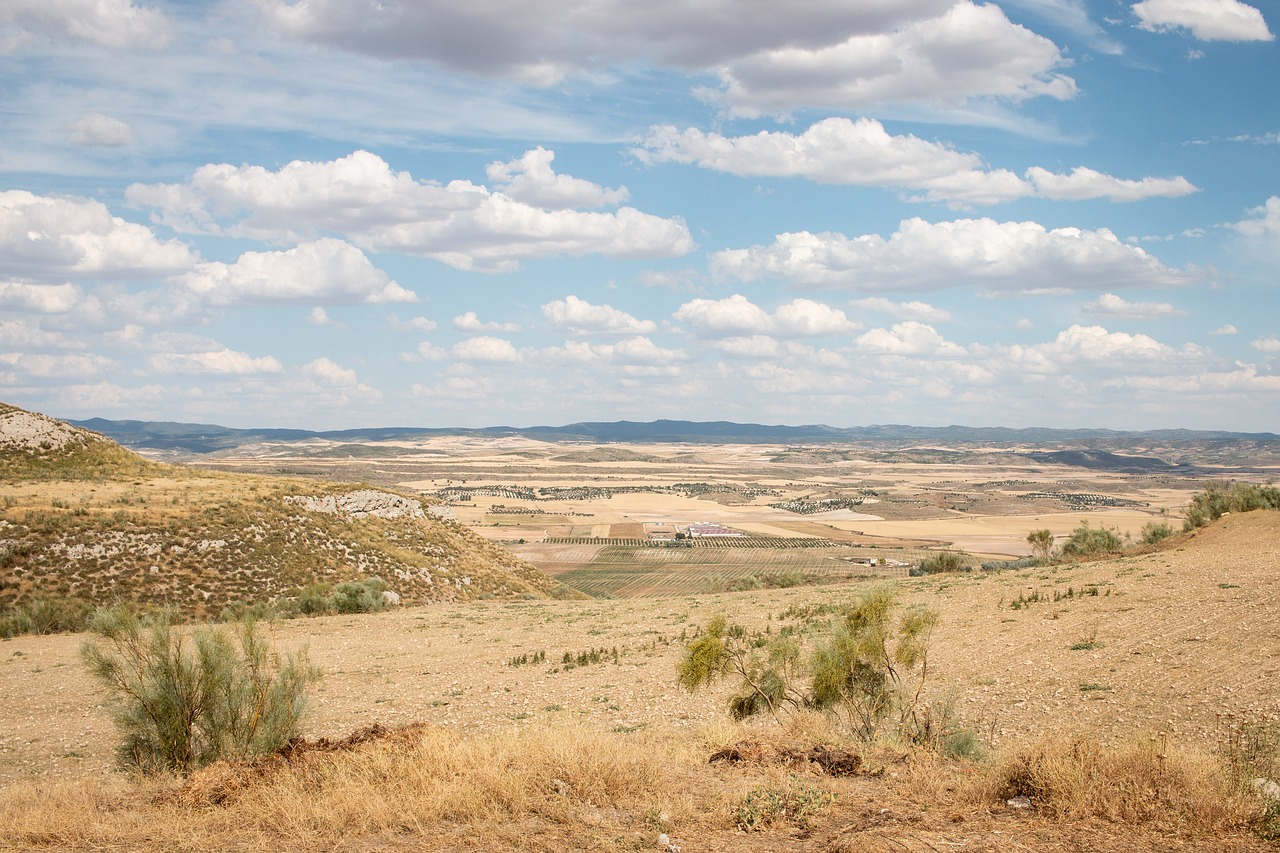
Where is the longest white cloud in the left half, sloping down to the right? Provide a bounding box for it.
[127,151,694,272]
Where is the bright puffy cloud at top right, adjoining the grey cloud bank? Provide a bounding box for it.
[701,0,1075,117]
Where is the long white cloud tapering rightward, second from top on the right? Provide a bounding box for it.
[634,118,1196,205]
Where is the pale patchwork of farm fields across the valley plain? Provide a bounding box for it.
[186,437,1249,597]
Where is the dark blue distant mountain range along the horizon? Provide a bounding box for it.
[68,418,1280,467]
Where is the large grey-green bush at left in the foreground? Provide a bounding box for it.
[81,608,320,774]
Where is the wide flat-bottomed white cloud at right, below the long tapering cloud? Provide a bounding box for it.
[712,218,1197,292]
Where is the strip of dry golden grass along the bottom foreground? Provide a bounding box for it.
[0,716,1270,852]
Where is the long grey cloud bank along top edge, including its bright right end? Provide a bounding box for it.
[255,0,1075,114]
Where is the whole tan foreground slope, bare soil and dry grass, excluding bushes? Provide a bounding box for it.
[0,511,1280,853]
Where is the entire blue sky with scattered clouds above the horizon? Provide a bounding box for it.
[0,0,1280,432]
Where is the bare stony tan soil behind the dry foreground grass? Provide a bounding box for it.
[0,512,1280,785]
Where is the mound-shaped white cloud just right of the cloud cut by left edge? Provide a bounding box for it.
[182,237,417,305]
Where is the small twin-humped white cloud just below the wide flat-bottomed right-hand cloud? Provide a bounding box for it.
[675,293,861,338]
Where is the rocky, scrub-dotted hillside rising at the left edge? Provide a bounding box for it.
[0,406,572,617]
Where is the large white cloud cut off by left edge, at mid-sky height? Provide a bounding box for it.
[0,190,197,280]
